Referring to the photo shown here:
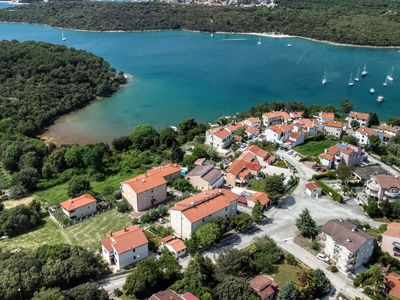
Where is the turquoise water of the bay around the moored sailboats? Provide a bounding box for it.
[0,24,400,142]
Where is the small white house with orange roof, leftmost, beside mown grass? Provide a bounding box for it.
[60,194,97,219]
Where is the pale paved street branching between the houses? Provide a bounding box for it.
[99,151,379,299]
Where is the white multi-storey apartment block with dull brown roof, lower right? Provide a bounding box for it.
[320,219,374,273]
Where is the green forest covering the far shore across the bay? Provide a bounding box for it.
[0,0,400,46]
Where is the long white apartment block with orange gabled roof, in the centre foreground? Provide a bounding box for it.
[169,189,239,238]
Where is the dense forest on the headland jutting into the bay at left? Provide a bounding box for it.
[0,41,125,136]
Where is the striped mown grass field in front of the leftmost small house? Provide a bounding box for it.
[0,210,132,251]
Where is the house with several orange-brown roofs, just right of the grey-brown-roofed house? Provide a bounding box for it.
[225,152,261,187]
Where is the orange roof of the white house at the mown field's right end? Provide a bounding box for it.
[101,226,149,254]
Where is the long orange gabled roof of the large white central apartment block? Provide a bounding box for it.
[170,190,239,223]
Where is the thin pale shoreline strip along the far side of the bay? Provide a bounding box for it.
[0,20,400,49]
